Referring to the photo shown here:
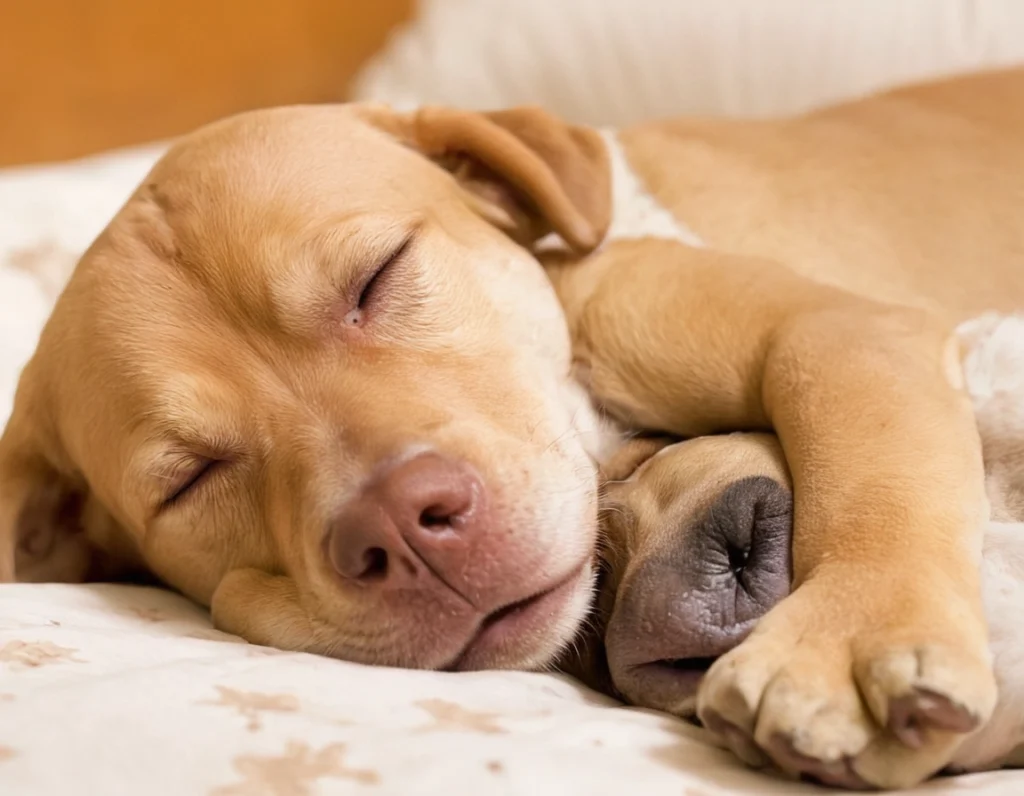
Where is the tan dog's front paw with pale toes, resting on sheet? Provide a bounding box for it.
[697,577,995,789]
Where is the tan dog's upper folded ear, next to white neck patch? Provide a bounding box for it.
[365,107,611,253]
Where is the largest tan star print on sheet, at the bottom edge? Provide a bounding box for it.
[210,741,380,796]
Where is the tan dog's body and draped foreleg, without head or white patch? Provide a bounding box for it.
[553,72,1024,786]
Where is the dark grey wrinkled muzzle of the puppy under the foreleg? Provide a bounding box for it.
[605,476,793,715]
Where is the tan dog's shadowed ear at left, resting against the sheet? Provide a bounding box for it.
[0,377,132,583]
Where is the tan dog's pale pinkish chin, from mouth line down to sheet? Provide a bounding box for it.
[442,559,595,671]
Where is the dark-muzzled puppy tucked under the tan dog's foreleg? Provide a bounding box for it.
[590,317,1024,786]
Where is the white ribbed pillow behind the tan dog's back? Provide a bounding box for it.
[354,0,1024,125]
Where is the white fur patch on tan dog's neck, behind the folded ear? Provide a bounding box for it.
[601,130,705,248]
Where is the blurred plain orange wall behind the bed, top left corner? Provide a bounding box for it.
[0,0,414,165]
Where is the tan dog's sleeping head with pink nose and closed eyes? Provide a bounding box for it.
[0,107,609,668]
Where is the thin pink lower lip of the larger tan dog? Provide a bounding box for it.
[442,559,591,672]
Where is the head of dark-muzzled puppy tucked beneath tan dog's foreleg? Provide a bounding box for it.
[599,433,793,716]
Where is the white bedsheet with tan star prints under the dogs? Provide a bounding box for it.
[0,148,1024,796]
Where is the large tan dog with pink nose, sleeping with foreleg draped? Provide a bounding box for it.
[0,72,1024,786]
